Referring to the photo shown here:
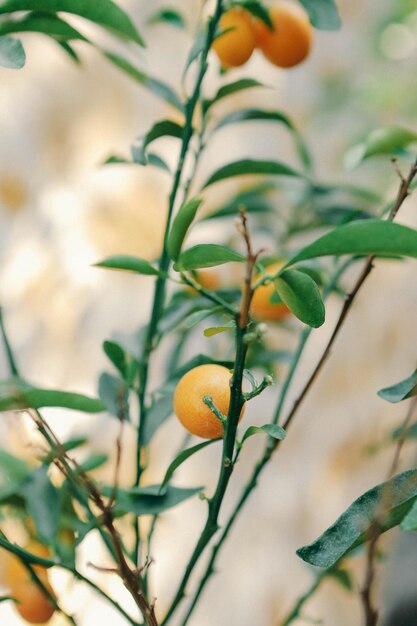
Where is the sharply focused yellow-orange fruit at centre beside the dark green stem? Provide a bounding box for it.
[174,364,244,439]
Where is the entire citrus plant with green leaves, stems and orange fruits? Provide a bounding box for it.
[0,0,417,626]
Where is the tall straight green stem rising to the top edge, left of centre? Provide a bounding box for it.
[134,0,222,564]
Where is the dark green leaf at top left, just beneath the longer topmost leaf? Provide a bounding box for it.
[0,13,88,42]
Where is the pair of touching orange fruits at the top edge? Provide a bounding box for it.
[213,0,313,68]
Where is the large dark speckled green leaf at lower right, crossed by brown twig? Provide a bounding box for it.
[297,469,417,567]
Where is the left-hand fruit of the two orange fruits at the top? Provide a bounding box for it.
[212,9,256,67]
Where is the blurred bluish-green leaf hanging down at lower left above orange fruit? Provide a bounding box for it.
[20,465,62,543]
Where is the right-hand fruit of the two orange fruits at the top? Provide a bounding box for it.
[255,0,313,68]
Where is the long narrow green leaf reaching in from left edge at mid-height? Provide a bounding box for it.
[0,377,105,413]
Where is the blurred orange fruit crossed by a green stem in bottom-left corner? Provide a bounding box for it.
[5,541,55,624]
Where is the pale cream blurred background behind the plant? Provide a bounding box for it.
[0,0,417,626]
